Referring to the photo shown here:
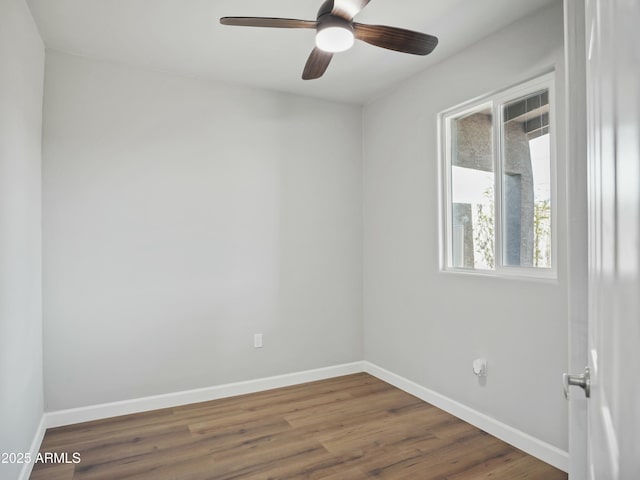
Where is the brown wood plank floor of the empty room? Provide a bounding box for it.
[31,373,567,480]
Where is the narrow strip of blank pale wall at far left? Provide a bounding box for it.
[0,0,44,479]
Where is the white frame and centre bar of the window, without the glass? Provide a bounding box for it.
[438,72,560,280]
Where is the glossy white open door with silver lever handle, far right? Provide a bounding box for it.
[575,0,640,480]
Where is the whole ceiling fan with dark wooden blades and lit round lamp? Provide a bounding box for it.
[220,0,438,80]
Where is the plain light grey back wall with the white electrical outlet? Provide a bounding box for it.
[43,52,363,411]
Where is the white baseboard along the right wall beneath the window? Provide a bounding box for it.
[363,361,569,472]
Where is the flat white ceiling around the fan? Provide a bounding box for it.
[27,0,559,103]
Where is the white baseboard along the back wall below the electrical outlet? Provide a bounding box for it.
[45,362,364,430]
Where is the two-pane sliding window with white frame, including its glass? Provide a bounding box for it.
[439,74,556,277]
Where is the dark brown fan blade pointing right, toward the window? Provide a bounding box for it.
[353,23,438,55]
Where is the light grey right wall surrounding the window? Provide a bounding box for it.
[363,2,567,451]
